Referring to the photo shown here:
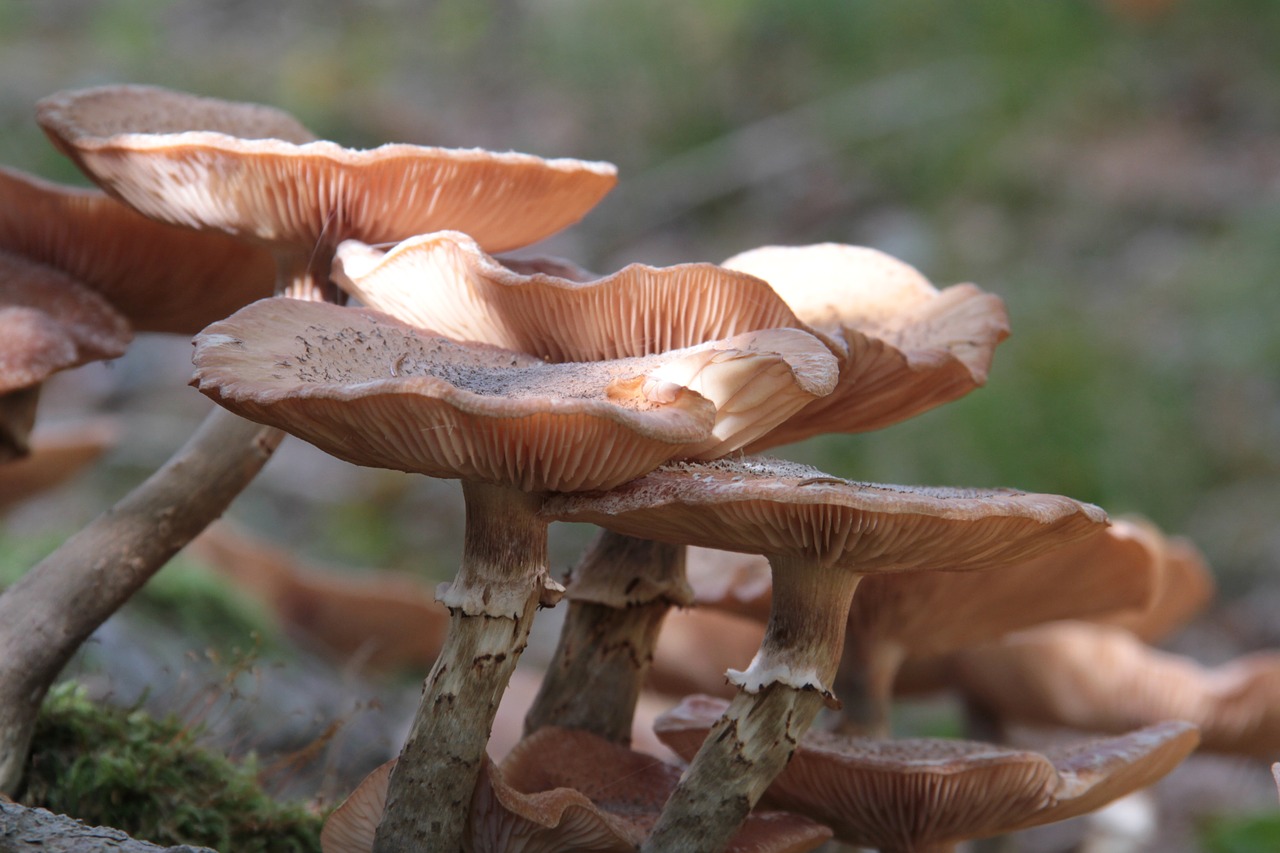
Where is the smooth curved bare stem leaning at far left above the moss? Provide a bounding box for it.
[0,409,284,792]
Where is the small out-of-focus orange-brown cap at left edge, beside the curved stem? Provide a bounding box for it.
[0,418,119,514]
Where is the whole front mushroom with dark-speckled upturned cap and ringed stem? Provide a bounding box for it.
[186,298,835,849]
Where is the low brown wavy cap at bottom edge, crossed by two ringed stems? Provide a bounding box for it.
[320,726,831,853]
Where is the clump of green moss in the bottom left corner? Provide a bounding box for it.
[22,683,323,853]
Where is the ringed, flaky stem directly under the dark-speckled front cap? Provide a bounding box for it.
[374,482,558,853]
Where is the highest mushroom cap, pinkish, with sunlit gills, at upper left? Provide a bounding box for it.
[37,86,617,251]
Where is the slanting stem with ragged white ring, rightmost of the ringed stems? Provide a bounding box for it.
[640,556,861,853]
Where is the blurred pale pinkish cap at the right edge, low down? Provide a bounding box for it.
[950,621,1280,758]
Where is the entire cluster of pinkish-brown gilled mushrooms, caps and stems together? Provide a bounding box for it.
[0,86,1244,853]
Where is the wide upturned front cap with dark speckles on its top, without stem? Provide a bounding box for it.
[186,298,833,492]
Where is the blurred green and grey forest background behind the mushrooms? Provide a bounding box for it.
[0,0,1280,845]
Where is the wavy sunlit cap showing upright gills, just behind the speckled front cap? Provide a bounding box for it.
[334,232,844,361]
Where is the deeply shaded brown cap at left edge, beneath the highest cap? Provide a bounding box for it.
[0,168,275,334]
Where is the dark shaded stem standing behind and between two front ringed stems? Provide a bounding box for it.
[525,530,692,745]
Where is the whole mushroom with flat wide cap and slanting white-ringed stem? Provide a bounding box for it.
[543,459,1107,850]
